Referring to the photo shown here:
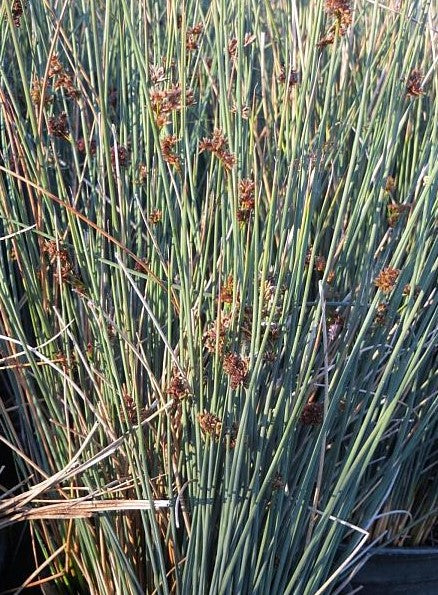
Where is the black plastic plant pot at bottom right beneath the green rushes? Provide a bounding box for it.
[351,547,438,595]
